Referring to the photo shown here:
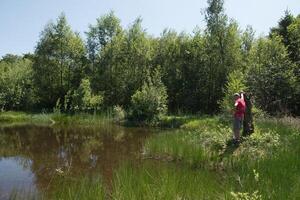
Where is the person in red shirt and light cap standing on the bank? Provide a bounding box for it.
[233,93,246,143]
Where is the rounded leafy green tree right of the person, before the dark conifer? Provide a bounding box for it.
[246,36,296,114]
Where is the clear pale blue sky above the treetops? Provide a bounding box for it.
[0,0,300,57]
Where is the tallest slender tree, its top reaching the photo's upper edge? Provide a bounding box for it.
[204,0,243,113]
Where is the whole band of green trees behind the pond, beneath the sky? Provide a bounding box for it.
[0,0,300,116]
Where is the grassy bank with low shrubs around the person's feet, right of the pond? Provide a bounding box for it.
[145,116,300,200]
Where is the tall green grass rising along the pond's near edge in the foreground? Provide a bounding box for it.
[10,162,230,200]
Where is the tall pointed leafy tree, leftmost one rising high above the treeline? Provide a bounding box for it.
[33,14,85,108]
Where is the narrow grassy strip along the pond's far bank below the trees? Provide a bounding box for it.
[0,111,228,129]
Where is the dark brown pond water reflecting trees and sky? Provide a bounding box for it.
[0,125,151,199]
